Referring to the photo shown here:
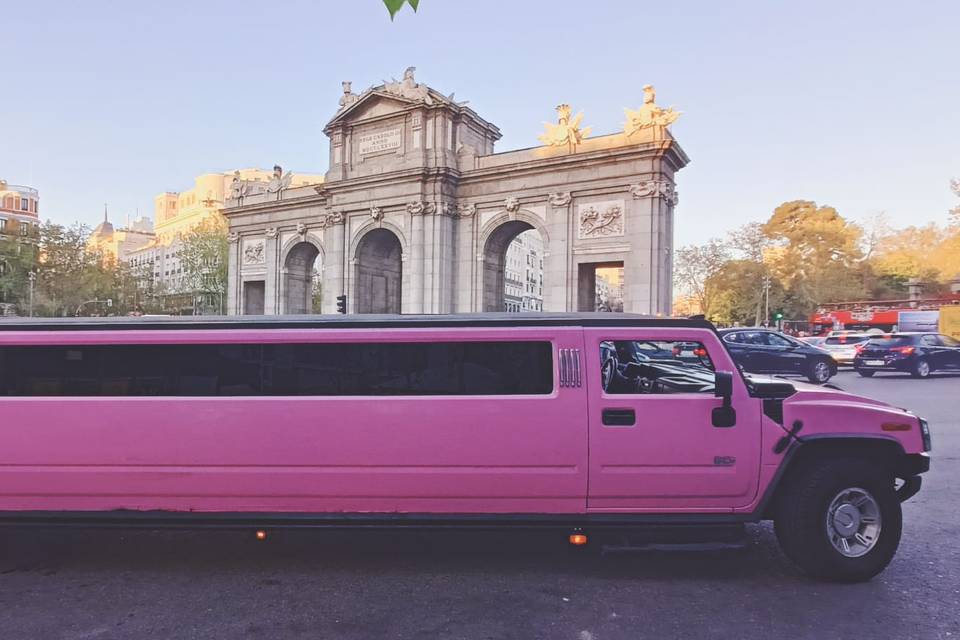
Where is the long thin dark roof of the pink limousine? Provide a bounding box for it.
[0,313,713,331]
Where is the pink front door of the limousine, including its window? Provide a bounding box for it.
[584,328,761,512]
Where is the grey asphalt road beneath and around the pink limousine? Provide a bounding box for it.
[0,372,960,640]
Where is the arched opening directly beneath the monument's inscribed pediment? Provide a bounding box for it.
[354,228,403,313]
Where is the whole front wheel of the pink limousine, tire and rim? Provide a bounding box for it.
[774,458,902,582]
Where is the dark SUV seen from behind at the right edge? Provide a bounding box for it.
[853,333,960,378]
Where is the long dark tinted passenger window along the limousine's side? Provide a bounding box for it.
[0,342,553,396]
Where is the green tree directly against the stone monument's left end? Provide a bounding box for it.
[178,215,230,313]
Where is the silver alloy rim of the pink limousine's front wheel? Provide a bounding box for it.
[826,487,881,558]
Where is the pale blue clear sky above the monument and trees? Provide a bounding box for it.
[0,0,960,246]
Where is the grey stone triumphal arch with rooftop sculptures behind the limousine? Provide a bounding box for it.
[224,68,688,314]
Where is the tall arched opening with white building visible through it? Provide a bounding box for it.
[482,220,543,312]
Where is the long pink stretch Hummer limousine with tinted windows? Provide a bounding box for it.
[0,313,930,581]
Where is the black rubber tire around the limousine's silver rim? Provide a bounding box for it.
[774,457,903,582]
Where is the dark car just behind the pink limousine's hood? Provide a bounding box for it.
[720,329,837,384]
